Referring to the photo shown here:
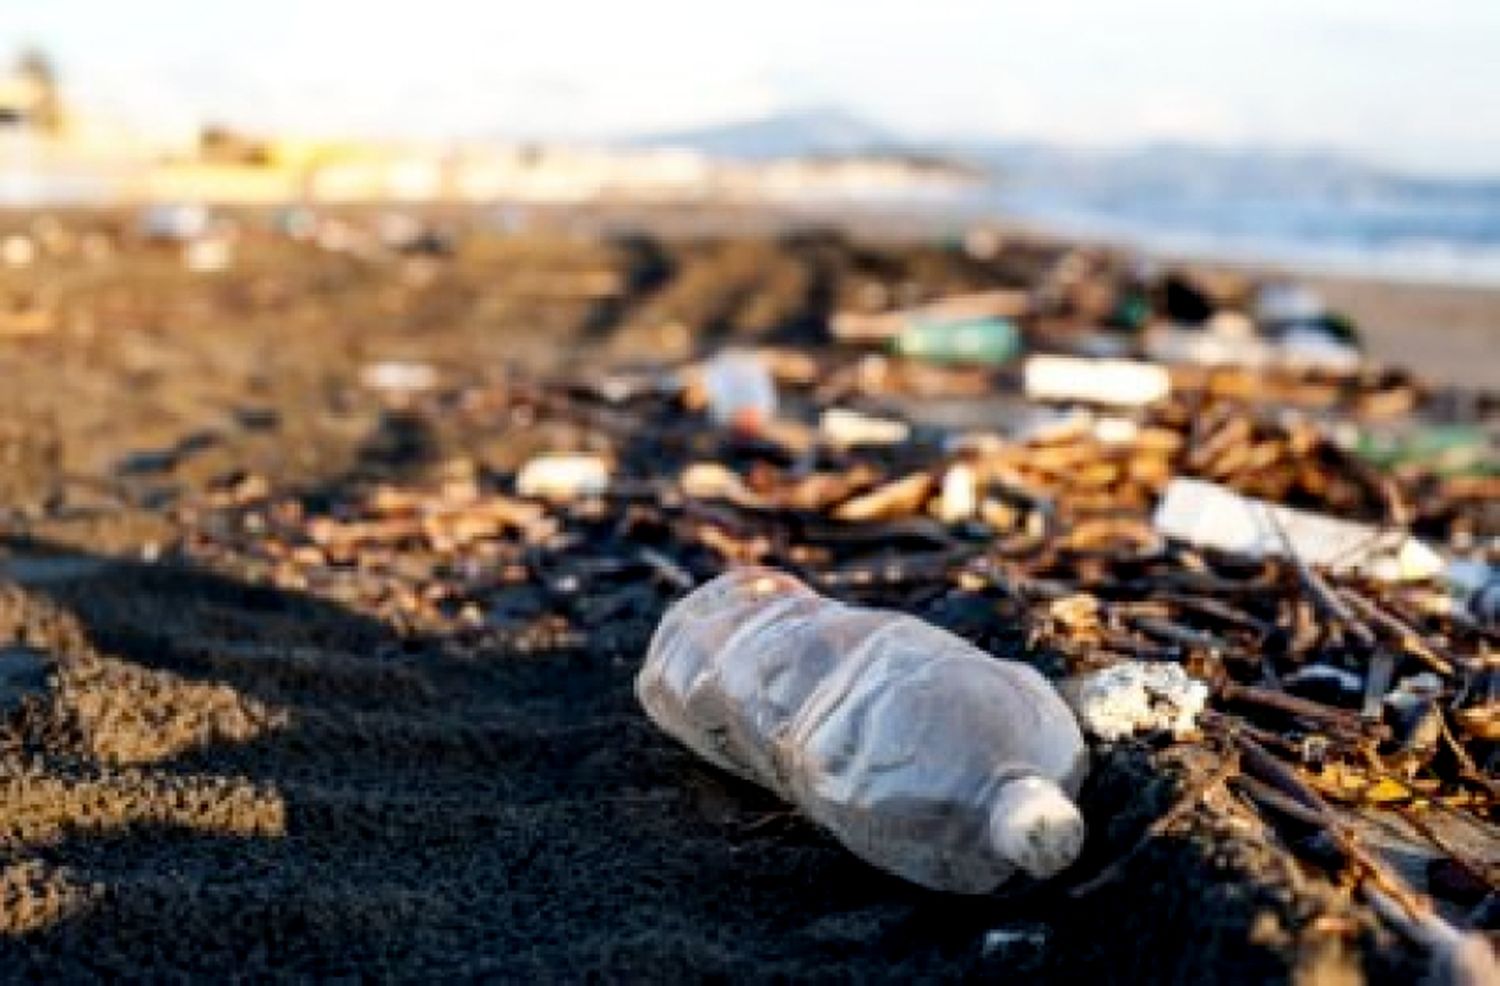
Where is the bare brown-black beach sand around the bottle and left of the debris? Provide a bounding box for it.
[0,219,1440,981]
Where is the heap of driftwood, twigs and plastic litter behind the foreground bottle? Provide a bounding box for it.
[182,265,1500,972]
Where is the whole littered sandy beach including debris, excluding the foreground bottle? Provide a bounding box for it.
[0,209,1500,981]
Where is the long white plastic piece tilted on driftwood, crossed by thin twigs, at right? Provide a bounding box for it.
[1155,477,1445,582]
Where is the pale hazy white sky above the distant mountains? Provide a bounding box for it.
[0,0,1500,176]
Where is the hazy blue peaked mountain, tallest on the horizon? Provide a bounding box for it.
[630,107,908,161]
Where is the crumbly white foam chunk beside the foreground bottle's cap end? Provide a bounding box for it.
[1061,660,1209,741]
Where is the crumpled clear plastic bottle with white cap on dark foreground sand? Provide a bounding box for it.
[636,567,1088,893]
